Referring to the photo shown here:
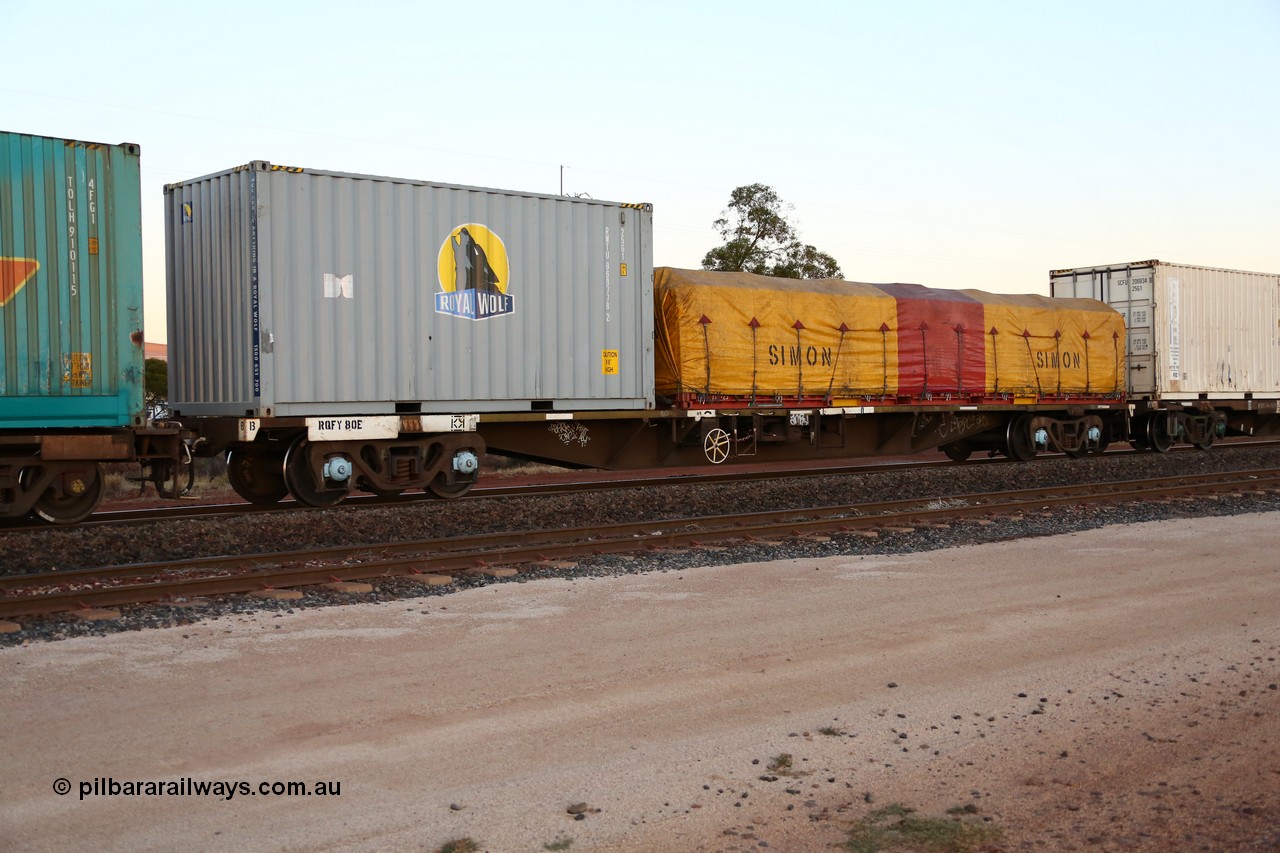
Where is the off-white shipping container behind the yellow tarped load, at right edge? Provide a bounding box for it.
[1050,260,1280,402]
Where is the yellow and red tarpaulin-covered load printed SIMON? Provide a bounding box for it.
[654,268,1125,406]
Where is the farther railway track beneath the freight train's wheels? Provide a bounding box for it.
[10,439,1280,532]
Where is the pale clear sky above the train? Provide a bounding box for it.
[0,0,1280,342]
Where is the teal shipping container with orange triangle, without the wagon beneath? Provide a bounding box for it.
[0,132,143,430]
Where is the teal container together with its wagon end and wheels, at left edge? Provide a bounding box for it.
[0,132,180,521]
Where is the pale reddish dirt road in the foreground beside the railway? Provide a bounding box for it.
[0,514,1280,852]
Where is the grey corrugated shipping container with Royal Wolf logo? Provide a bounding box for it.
[165,161,654,418]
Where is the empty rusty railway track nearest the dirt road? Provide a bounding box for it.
[0,469,1280,619]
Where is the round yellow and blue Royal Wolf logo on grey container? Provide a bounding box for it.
[435,223,516,320]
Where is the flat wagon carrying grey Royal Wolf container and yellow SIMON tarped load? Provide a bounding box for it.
[165,161,1124,506]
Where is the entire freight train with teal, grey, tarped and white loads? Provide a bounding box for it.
[0,133,1280,523]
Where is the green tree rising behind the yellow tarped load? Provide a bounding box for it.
[703,183,841,278]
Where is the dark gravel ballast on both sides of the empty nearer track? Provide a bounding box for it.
[0,447,1280,647]
